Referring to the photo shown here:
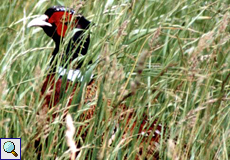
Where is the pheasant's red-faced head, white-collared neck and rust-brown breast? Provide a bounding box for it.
[28,6,93,109]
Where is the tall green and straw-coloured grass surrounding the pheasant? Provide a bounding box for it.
[0,0,230,160]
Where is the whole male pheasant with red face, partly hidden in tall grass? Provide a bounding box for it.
[28,6,161,159]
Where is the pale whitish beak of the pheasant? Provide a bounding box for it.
[27,15,52,28]
